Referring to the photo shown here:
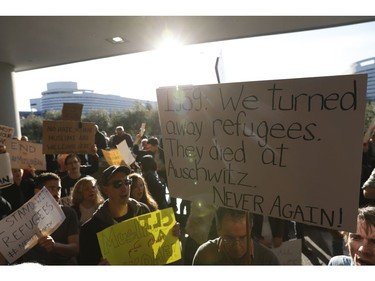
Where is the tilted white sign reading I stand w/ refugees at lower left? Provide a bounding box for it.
[0,187,65,263]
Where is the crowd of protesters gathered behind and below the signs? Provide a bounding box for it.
[0,126,375,265]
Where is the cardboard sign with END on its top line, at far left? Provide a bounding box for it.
[7,139,46,171]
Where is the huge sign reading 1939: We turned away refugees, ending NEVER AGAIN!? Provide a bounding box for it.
[157,74,367,231]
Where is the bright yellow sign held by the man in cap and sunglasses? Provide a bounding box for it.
[97,208,181,265]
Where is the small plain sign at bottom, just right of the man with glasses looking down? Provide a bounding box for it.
[271,239,302,265]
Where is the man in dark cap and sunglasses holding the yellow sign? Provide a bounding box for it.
[78,163,150,265]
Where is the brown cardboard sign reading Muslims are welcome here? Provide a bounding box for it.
[43,118,96,154]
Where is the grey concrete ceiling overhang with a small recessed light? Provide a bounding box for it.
[0,16,375,72]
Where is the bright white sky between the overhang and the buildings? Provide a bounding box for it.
[14,22,375,111]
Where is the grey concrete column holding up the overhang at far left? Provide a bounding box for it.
[0,62,21,137]
